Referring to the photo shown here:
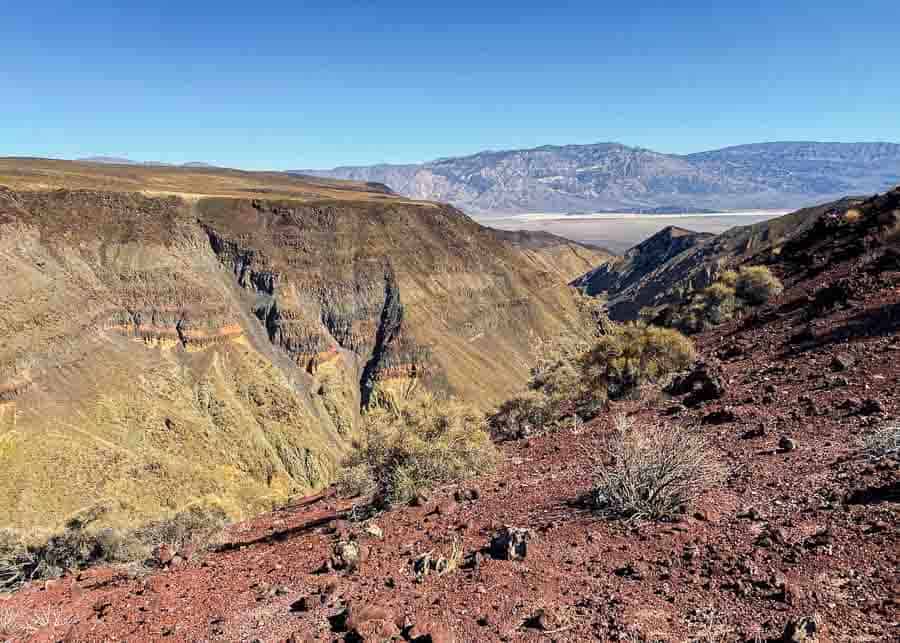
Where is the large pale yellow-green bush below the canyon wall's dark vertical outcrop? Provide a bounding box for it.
[344,392,496,507]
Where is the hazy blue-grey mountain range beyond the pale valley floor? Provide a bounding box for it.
[291,142,900,214]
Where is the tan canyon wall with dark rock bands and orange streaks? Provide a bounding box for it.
[0,171,602,526]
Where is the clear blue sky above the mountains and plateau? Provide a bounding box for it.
[0,0,900,169]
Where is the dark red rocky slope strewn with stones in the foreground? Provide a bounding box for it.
[0,184,900,643]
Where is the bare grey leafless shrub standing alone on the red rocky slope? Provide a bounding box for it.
[590,417,723,520]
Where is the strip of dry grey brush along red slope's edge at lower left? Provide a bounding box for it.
[0,506,226,591]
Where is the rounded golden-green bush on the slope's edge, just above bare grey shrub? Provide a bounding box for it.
[581,323,696,399]
